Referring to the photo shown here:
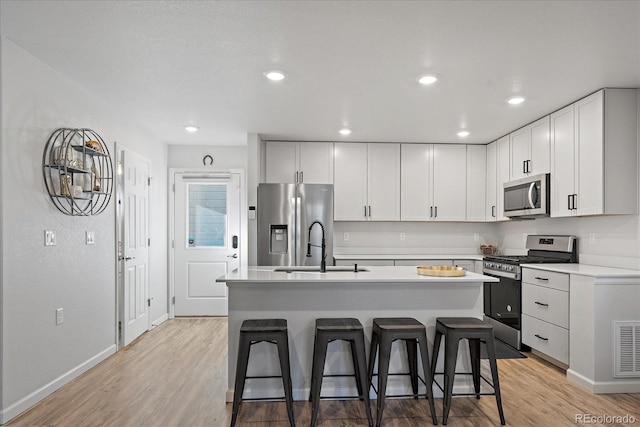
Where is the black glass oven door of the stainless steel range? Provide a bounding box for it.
[483,272,522,330]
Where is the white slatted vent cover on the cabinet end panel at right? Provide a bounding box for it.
[613,321,640,377]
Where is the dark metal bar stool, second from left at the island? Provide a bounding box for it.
[309,318,373,426]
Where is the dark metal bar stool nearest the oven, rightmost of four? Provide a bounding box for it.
[431,317,505,425]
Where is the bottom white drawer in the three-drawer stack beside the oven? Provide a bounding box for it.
[522,314,569,365]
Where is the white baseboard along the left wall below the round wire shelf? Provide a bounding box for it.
[0,344,116,424]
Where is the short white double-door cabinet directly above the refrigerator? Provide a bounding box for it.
[265,141,333,184]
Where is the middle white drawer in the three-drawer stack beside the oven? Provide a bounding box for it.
[522,283,569,328]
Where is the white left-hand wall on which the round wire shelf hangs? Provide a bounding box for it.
[0,38,167,422]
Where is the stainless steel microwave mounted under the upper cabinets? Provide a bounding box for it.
[504,173,551,218]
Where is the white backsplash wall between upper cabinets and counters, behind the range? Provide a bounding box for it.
[334,215,640,269]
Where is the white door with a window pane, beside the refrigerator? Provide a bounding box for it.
[174,172,240,316]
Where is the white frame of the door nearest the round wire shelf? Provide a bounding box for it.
[114,142,153,351]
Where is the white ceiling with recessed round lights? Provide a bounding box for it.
[0,0,640,145]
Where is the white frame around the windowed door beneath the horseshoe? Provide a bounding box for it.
[167,168,249,319]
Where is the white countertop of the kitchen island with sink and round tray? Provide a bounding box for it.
[217,266,499,285]
